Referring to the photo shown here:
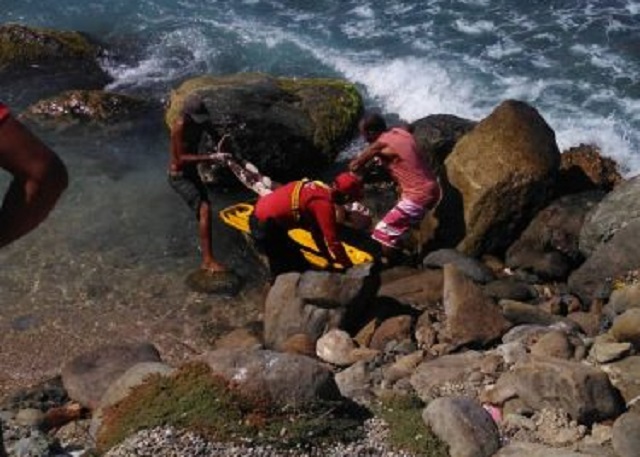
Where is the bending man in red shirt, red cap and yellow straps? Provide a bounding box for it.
[251,172,363,278]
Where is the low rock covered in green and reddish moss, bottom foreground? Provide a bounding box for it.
[96,363,366,453]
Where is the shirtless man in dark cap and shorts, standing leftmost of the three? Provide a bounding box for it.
[169,95,231,272]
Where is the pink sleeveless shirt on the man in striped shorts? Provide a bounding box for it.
[378,128,440,207]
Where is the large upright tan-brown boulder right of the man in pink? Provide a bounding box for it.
[437,100,560,256]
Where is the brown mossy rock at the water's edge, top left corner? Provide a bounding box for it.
[0,24,100,68]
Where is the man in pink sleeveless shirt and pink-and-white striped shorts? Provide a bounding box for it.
[349,113,442,261]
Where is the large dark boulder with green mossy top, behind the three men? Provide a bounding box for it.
[165,73,363,181]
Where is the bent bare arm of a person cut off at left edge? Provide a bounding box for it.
[0,103,69,248]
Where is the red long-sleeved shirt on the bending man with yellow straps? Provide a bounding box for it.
[254,181,351,266]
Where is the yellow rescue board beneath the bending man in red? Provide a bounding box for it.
[220,203,373,269]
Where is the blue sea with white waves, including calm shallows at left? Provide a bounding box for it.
[0,0,640,388]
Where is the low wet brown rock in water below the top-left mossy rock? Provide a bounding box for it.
[21,90,150,124]
